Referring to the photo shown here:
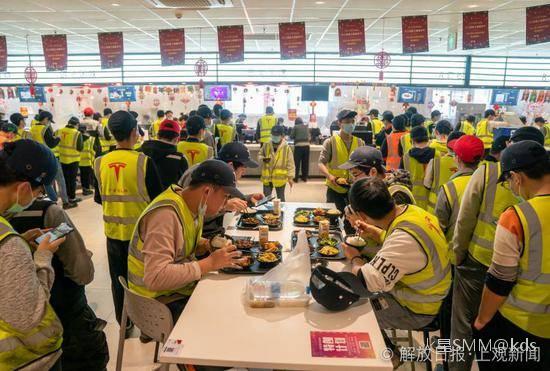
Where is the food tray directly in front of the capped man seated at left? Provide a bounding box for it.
[221,241,283,274]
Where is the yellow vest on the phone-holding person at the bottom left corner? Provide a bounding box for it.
[0,216,63,370]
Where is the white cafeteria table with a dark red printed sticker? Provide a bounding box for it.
[160,202,392,371]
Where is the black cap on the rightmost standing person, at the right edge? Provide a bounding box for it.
[498,140,548,182]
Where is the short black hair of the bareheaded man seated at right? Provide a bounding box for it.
[349,177,395,220]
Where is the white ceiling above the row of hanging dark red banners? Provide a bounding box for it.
[0,0,550,56]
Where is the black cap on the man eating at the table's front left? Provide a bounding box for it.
[189,160,246,200]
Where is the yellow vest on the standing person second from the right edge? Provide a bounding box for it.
[466,162,518,267]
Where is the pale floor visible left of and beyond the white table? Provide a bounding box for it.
[69,179,448,371]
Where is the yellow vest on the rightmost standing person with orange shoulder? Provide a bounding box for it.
[499,195,550,339]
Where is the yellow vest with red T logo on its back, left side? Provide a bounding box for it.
[94,150,151,241]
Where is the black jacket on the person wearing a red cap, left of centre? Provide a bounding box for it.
[140,140,189,189]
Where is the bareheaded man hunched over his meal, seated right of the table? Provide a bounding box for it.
[344,177,451,330]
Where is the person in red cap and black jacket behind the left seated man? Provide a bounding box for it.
[140,119,189,189]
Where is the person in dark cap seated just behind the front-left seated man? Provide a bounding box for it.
[178,142,264,238]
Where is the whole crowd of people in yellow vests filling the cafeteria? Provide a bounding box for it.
[0,100,550,370]
